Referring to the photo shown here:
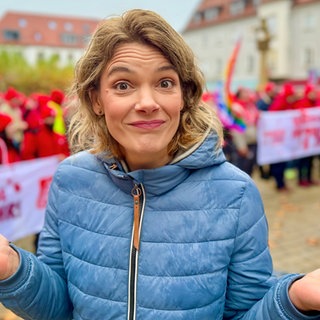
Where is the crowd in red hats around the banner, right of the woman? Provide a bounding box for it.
[208,82,320,191]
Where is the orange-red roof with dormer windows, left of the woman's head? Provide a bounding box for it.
[0,11,99,48]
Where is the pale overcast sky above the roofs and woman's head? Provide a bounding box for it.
[0,0,201,31]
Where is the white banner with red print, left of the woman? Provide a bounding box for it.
[0,156,59,241]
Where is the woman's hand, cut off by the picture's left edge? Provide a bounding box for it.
[0,234,20,280]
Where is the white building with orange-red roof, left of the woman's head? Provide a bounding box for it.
[0,11,99,65]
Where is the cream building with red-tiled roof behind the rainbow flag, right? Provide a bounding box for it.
[182,0,320,89]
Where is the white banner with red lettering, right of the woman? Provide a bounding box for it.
[257,107,320,165]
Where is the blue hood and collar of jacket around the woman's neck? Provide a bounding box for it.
[103,134,226,195]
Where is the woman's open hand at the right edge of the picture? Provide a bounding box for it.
[289,269,320,312]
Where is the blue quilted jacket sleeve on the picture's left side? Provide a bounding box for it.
[0,166,72,320]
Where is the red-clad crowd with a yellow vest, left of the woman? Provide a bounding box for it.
[0,87,70,164]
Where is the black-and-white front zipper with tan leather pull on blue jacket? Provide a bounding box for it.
[128,184,145,320]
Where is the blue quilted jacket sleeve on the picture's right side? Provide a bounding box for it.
[224,181,319,320]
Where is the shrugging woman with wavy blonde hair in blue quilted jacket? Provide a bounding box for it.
[0,10,320,320]
